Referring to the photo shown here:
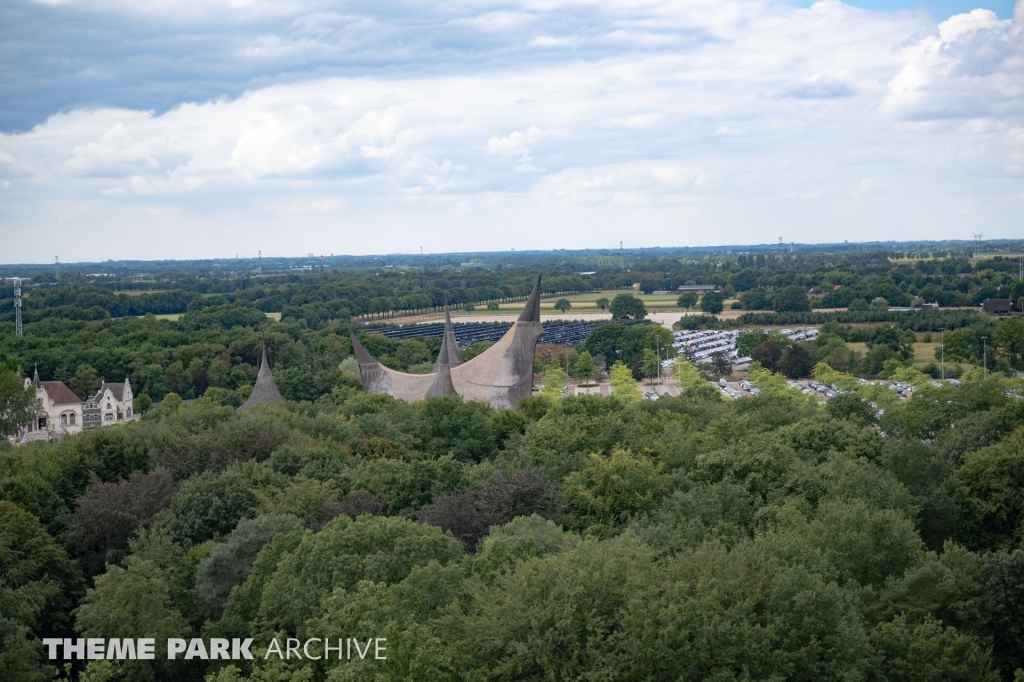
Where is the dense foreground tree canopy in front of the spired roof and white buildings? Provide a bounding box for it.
[0,360,1024,681]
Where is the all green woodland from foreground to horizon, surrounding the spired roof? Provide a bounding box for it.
[0,246,1024,682]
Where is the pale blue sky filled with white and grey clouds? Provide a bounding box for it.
[0,0,1024,263]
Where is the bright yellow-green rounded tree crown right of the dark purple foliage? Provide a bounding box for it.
[563,450,672,537]
